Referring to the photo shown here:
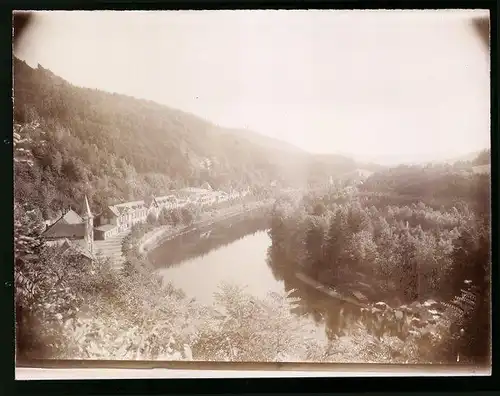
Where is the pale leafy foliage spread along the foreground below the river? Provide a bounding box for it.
[12,235,458,363]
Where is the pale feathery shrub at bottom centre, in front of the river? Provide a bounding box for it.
[193,284,326,362]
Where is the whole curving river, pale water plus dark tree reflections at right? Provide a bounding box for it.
[148,213,454,364]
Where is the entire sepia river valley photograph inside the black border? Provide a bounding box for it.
[12,10,491,370]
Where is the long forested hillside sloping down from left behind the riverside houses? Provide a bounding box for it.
[14,59,378,217]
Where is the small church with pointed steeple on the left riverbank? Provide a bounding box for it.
[42,196,95,262]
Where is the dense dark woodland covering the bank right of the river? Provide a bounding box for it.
[269,162,491,363]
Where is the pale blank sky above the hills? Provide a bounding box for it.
[15,10,490,163]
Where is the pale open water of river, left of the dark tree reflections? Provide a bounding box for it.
[149,216,284,304]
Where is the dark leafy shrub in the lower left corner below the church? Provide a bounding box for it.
[16,238,101,358]
